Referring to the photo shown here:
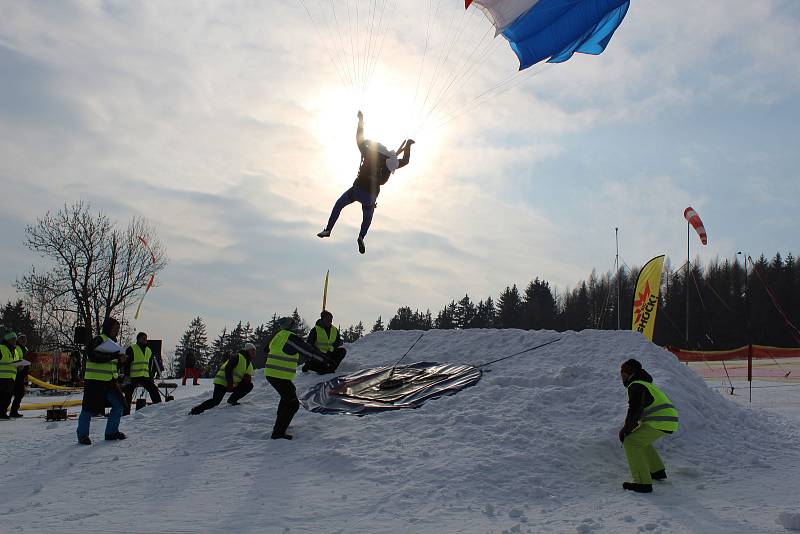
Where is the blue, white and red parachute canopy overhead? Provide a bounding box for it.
[465,0,630,70]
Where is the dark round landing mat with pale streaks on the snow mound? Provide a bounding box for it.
[300,362,482,416]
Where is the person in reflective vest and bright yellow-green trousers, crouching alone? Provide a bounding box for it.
[619,359,678,493]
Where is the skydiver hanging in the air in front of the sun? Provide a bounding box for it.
[317,111,414,254]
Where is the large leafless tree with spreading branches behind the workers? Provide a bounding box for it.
[17,201,167,345]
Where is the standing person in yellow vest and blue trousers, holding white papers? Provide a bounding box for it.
[77,317,127,445]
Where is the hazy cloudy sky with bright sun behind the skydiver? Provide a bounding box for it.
[0,0,800,346]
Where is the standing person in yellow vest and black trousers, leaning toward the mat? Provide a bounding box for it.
[264,317,326,439]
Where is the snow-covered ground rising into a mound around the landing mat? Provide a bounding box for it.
[0,330,800,534]
